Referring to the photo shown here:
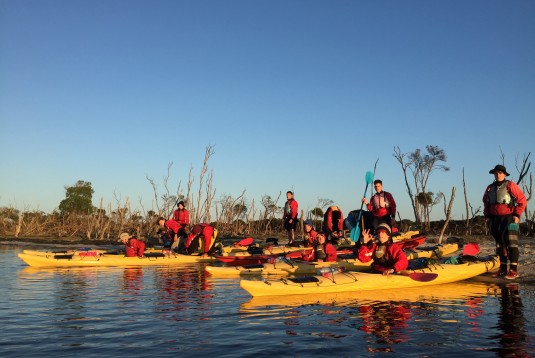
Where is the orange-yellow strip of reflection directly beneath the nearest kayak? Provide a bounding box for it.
[241,282,500,309]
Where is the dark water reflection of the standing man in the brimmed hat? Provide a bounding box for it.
[494,284,533,357]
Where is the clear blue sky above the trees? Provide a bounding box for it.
[0,0,535,219]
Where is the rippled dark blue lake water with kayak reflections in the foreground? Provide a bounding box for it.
[0,244,535,357]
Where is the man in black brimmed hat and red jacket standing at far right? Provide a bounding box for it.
[483,164,527,280]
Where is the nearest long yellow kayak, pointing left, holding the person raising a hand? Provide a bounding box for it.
[240,256,499,296]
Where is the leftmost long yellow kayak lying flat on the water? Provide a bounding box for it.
[18,252,215,267]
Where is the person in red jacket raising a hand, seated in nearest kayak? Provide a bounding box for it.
[357,223,409,275]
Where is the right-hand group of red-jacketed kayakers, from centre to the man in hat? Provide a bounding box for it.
[283,164,527,280]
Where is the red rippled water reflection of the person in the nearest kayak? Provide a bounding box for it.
[359,302,411,352]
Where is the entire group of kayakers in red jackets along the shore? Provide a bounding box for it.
[118,165,527,280]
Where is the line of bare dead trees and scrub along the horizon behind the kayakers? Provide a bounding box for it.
[0,145,535,240]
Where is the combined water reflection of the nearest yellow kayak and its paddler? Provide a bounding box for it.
[241,283,500,352]
